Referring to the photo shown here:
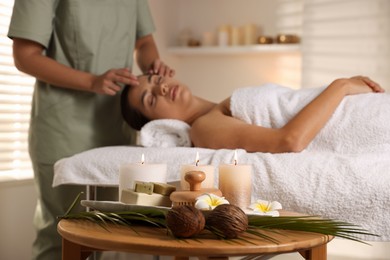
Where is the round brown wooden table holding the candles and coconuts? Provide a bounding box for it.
[58,219,332,260]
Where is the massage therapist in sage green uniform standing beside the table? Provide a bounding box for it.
[8,0,174,260]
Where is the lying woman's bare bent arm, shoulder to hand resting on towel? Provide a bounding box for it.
[191,77,383,153]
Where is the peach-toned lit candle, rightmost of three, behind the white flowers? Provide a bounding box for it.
[219,151,252,210]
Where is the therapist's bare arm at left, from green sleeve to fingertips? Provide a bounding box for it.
[13,38,138,95]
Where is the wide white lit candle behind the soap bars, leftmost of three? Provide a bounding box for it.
[119,154,167,201]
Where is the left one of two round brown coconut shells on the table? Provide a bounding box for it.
[166,205,206,238]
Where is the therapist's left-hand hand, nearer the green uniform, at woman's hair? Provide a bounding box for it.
[91,68,139,96]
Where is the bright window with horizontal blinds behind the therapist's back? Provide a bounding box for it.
[0,0,34,177]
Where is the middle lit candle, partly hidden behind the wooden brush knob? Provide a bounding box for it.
[180,152,214,190]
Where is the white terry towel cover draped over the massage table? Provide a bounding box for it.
[53,146,390,241]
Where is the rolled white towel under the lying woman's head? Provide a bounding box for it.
[140,119,191,148]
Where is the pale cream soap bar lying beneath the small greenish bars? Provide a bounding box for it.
[121,189,172,207]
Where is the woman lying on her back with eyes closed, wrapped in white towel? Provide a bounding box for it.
[121,75,390,154]
